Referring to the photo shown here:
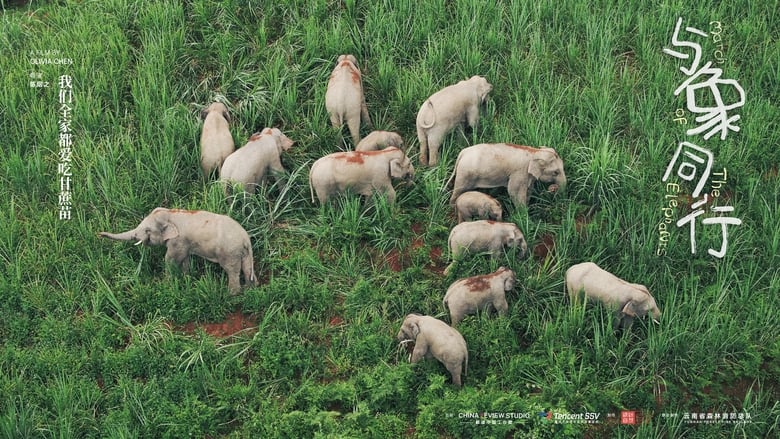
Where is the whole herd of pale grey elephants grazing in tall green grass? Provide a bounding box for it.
[99,55,661,386]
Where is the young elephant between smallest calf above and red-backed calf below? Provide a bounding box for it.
[444,220,528,275]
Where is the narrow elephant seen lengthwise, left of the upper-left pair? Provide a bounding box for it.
[200,102,236,177]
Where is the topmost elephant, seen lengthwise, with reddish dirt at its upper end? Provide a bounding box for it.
[325,55,373,145]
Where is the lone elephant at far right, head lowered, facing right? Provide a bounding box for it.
[565,262,661,329]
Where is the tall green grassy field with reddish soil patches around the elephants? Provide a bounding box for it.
[0,0,780,438]
